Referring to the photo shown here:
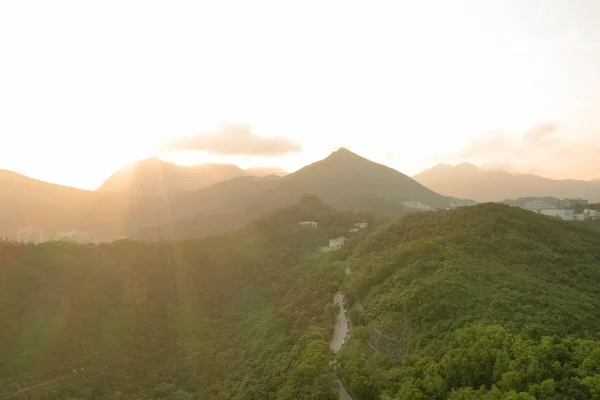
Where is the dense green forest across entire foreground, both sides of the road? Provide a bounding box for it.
[7,202,600,400]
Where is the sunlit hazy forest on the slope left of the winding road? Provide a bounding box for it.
[0,196,364,400]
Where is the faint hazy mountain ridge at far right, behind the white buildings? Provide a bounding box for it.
[414,163,600,202]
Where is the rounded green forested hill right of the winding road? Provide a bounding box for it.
[343,204,600,400]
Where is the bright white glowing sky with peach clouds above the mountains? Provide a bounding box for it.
[0,0,600,189]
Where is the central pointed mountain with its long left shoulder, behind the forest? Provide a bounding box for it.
[136,148,455,239]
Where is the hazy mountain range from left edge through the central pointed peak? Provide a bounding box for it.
[0,148,458,239]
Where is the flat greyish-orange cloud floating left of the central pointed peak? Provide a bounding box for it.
[162,123,302,157]
